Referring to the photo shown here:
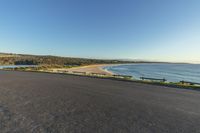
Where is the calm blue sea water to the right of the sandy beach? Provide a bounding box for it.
[104,63,200,83]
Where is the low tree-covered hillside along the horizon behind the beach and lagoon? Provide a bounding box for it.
[0,53,133,66]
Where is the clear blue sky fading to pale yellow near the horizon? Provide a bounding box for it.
[0,0,200,63]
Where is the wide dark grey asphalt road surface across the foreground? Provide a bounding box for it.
[0,71,200,133]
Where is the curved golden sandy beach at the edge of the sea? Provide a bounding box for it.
[53,64,113,76]
